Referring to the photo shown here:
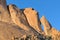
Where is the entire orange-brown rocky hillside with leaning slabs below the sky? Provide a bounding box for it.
[0,0,60,40]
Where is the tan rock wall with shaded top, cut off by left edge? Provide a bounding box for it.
[0,0,11,22]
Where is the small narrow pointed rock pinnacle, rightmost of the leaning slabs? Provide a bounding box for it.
[40,16,52,35]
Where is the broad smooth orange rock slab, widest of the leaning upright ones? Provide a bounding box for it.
[24,8,42,33]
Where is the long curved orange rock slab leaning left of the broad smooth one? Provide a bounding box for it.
[9,5,30,31]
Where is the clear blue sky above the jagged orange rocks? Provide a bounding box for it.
[7,0,60,30]
